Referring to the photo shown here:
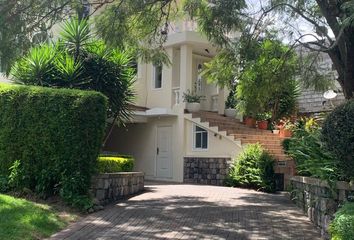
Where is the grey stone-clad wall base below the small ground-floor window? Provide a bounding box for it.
[184,157,231,186]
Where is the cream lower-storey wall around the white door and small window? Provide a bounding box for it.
[104,116,241,182]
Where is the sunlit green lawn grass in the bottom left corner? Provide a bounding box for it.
[0,194,75,240]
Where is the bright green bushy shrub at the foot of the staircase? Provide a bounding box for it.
[227,143,275,192]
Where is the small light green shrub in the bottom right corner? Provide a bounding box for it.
[330,202,354,240]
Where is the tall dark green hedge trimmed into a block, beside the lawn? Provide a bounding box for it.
[0,84,107,208]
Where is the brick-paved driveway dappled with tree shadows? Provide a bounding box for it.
[51,183,320,240]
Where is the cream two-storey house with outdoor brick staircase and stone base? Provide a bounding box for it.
[104,21,294,189]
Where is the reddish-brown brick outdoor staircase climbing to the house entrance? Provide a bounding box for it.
[192,111,290,161]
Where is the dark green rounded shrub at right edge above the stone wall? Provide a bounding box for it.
[322,100,354,179]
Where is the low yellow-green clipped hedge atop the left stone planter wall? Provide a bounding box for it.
[98,156,134,173]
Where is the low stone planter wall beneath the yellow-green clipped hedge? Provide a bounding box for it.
[91,172,144,205]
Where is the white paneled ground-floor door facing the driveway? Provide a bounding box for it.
[156,126,172,178]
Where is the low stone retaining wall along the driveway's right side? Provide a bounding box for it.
[290,176,354,239]
